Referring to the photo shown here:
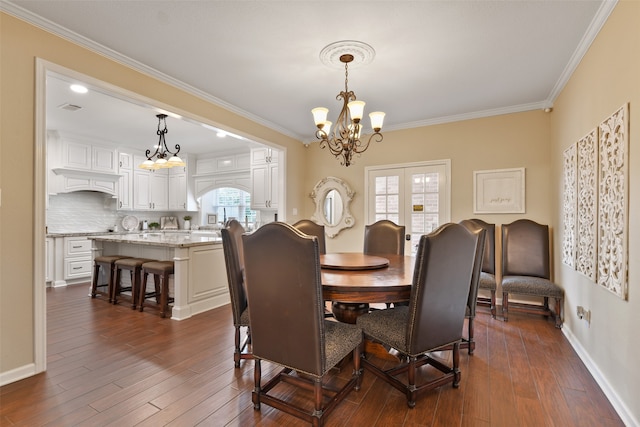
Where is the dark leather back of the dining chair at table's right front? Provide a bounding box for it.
[406,223,482,355]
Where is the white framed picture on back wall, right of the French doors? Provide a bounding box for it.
[473,168,526,214]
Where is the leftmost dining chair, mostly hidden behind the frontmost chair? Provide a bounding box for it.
[220,219,253,368]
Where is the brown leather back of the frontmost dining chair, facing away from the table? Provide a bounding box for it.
[242,222,325,376]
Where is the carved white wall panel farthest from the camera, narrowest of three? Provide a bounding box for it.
[562,144,577,267]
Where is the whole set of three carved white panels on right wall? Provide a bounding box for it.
[562,104,629,299]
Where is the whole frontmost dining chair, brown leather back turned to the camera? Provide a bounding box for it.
[242,222,362,426]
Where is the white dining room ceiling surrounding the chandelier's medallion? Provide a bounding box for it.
[0,0,616,152]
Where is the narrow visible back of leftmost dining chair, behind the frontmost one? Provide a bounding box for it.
[220,219,247,325]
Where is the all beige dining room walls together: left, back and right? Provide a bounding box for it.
[0,1,640,424]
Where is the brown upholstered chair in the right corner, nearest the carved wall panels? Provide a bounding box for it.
[502,219,564,328]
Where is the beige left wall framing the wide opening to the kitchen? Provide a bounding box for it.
[0,13,304,373]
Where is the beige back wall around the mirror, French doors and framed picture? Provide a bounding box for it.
[303,111,553,251]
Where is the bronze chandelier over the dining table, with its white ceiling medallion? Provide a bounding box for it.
[311,41,385,166]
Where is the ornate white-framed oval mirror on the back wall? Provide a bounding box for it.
[309,176,355,238]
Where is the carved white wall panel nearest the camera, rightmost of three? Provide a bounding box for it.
[598,104,629,299]
